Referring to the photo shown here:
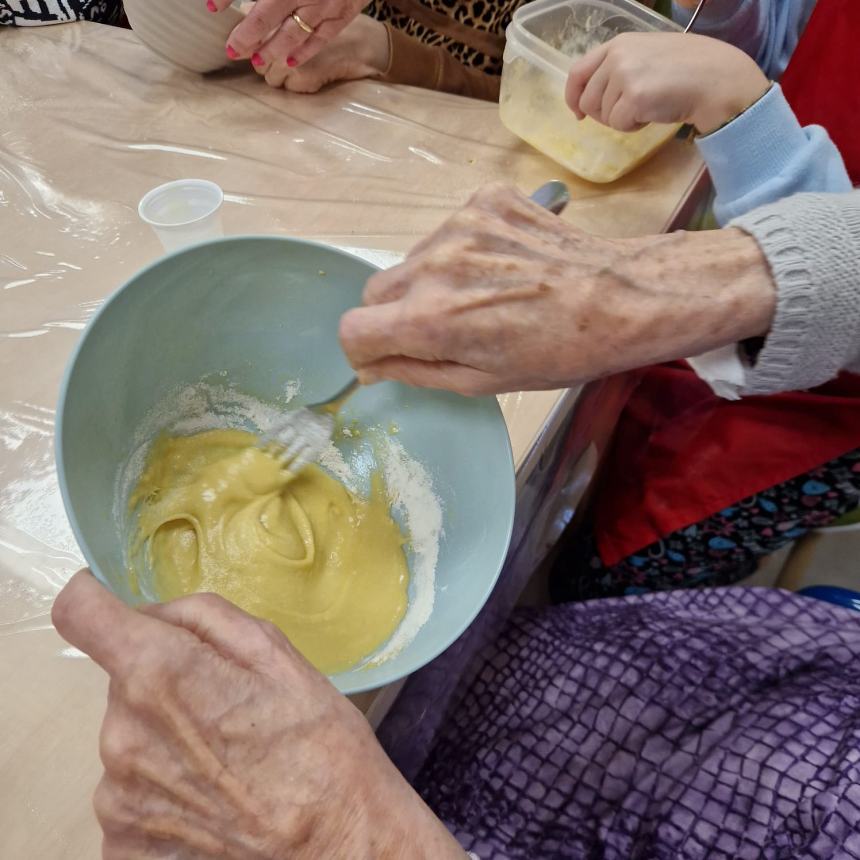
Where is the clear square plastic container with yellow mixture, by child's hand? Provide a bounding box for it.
[499,0,680,182]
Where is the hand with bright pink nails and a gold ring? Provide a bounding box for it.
[214,0,367,68]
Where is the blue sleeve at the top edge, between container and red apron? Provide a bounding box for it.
[672,0,816,80]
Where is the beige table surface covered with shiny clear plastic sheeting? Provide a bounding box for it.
[0,24,701,860]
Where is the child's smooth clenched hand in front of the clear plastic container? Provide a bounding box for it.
[566,33,770,134]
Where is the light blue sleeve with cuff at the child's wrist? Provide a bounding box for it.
[697,84,851,225]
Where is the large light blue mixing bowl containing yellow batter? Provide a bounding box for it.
[57,237,514,693]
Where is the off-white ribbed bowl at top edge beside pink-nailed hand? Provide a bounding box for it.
[124,0,243,72]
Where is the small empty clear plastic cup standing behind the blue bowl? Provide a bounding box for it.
[137,179,224,251]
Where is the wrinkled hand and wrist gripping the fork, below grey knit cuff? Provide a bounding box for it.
[340,186,775,394]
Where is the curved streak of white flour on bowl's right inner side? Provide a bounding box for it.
[369,437,442,666]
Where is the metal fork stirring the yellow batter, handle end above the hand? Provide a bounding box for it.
[263,180,570,472]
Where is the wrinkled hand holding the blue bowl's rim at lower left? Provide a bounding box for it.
[53,572,462,860]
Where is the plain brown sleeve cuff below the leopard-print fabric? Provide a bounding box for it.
[381,24,501,102]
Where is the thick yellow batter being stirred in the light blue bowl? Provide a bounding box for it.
[130,430,408,673]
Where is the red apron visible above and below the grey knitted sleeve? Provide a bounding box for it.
[594,0,860,566]
